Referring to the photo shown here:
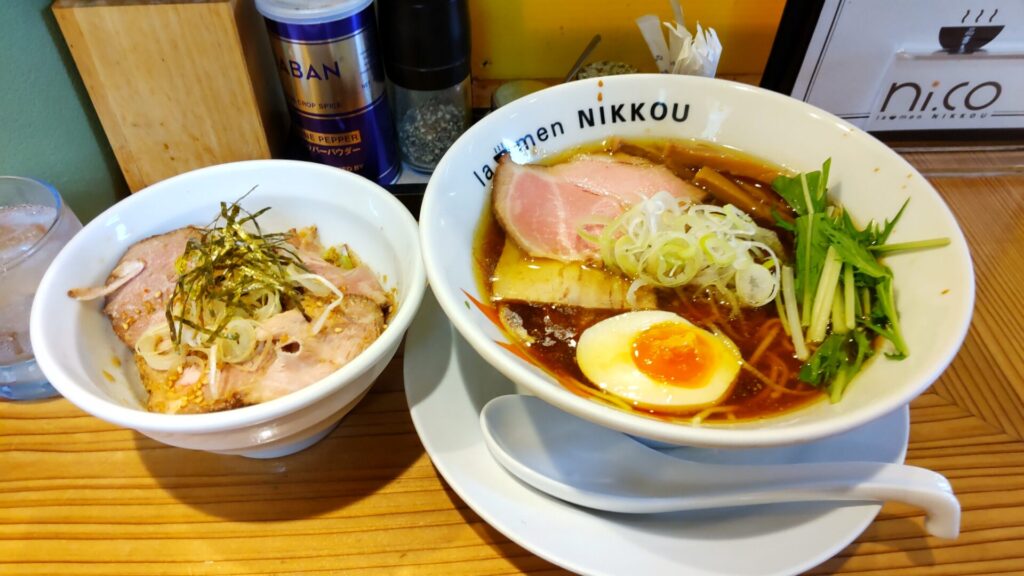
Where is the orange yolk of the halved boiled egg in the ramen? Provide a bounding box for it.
[633,323,715,387]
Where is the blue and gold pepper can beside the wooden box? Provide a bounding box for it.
[256,0,400,183]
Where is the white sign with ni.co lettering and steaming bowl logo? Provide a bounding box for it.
[776,0,1024,131]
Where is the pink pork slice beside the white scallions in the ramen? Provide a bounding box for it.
[493,154,705,261]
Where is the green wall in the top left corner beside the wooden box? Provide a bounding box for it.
[0,0,128,222]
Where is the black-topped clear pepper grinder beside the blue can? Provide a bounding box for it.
[377,0,472,172]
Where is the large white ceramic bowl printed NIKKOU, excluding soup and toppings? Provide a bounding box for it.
[420,75,974,447]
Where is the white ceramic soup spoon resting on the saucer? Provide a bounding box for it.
[480,395,961,538]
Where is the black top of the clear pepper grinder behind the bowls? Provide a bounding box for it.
[377,0,470,90]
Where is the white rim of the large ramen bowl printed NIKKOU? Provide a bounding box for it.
[420,74,976,448]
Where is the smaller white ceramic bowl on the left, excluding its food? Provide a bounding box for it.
[31,160,426,457]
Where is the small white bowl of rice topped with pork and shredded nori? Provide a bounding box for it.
[31,160,425,457]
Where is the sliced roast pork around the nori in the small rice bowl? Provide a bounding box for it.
[71,213,392,413]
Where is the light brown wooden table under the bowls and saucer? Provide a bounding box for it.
[0,149,1024,576]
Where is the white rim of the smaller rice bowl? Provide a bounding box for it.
[30,159,427,434]
